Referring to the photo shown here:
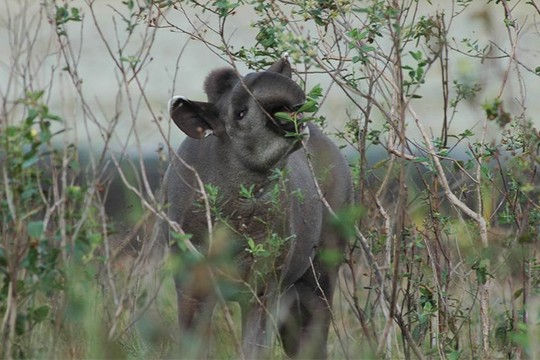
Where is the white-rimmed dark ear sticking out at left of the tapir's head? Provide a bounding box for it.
[169,96,224,139]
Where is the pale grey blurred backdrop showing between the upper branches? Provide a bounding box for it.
[0,0,540,154]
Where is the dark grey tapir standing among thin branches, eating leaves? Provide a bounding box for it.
[165,58,353,359]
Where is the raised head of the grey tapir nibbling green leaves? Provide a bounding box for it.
[169,58,308,172]
